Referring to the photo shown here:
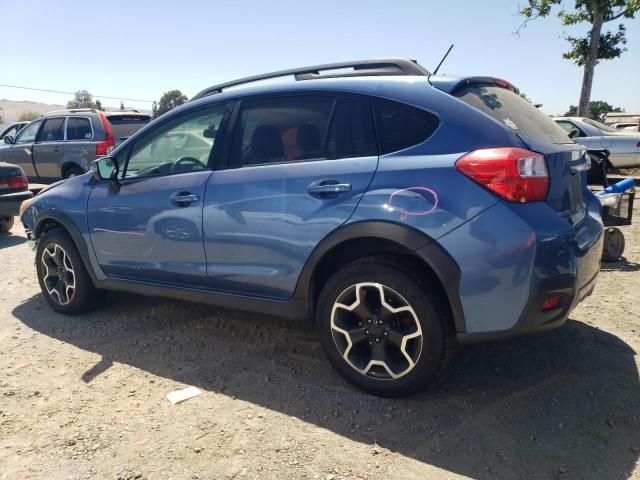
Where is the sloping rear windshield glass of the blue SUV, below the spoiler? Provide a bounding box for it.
[456,85,572,143]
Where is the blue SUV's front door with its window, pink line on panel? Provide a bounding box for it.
[87,104,227,286]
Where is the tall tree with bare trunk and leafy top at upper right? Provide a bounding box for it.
[518,0,640,116]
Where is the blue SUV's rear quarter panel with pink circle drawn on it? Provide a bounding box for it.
[350,84,524,243]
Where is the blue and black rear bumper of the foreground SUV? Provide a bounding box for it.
[439,199,604,343]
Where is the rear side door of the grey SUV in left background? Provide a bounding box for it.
[33,117,66,181]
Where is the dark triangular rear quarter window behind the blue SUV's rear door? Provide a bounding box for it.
[373,98,438,155]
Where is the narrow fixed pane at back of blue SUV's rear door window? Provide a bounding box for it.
[327,97,378,158]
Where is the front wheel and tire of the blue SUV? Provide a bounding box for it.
[36,229,100,315]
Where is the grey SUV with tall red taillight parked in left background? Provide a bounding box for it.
[0,108,151,183]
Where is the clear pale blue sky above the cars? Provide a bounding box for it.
[0,0,640,114]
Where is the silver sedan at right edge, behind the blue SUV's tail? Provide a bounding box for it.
[554,117,640,168]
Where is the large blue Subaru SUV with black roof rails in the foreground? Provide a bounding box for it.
[21,59,603,396]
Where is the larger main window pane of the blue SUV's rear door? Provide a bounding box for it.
[231,96,334,166]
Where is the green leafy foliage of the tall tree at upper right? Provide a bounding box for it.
[519,0,640,66]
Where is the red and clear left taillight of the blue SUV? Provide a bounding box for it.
[456,147,549,203]
